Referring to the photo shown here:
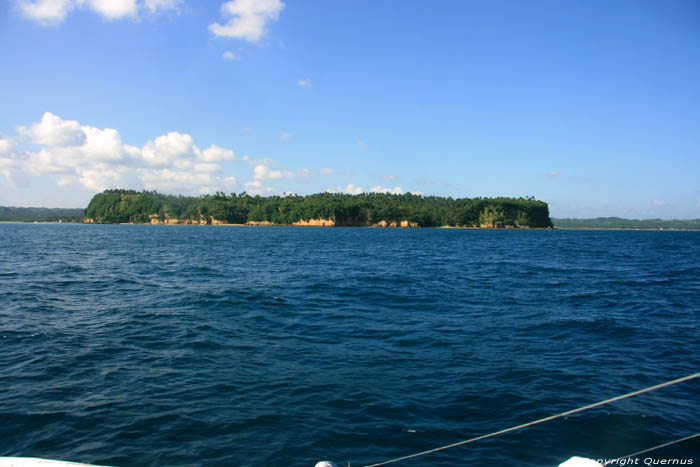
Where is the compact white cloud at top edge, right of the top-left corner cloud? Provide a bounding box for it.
[209,0,284,43]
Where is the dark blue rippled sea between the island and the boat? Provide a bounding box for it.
[0,224,700,466]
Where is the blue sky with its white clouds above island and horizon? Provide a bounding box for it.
[0,0,700,218]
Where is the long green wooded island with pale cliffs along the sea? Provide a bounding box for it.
[85,190,552,228]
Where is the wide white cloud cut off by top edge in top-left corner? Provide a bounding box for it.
[15,0,184,25]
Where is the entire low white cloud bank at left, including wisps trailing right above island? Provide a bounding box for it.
[7,112,348,203]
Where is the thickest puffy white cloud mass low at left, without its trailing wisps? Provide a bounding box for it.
[7,112,243,194]
